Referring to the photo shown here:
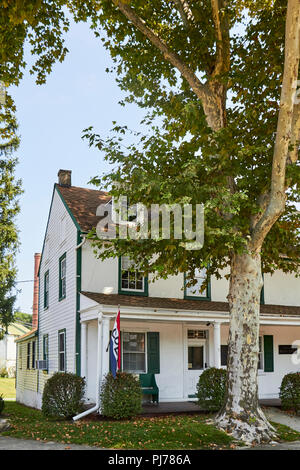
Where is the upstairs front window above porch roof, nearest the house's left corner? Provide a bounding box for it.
[119,256,148,295]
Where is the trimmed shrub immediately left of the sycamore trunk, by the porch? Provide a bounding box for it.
[196,367,226,411]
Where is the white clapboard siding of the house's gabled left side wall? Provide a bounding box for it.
[39,191,77,393]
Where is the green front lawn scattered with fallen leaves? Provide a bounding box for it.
[3,402,300,450]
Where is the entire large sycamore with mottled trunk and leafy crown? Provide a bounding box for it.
[71,0,300,442]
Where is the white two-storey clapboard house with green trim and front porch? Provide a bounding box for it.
[17,170,300,408]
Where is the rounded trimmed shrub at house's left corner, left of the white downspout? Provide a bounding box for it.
[42,372,85,419]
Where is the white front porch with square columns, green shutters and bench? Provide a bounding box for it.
[80,294,300,404]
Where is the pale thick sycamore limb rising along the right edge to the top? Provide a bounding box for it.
[251,0,300,251]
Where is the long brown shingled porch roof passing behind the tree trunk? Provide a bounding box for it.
[81,292,300,316]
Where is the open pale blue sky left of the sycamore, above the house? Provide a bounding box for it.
[9,18,146,313]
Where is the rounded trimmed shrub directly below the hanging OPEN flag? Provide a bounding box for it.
[100,372,142,419]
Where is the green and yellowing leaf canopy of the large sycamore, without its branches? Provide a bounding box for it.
[72,0,300,282]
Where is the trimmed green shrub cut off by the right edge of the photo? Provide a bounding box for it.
[279,372,300,414]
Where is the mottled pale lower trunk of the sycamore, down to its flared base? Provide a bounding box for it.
[216,254,275,443]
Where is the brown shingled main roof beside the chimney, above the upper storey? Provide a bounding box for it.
[55,184,111,232]
